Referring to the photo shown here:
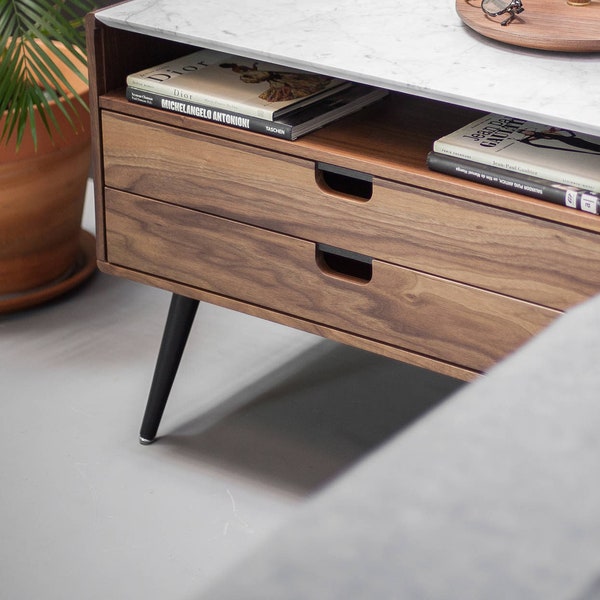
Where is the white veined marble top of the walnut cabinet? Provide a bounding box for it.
[98,0,600,135]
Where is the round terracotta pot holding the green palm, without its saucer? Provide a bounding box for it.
[0,41,90,294]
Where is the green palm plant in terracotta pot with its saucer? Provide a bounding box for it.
[0,0,95,312]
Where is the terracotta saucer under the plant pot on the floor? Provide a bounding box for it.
[0,229,96,314]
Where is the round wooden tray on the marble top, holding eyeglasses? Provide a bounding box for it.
[456,0,600,52]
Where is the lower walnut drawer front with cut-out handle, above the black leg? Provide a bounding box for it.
[106,189,558,371]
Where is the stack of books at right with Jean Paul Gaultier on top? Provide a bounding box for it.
[427,114,600,215]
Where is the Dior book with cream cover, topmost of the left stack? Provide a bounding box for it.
[127,50,349,121]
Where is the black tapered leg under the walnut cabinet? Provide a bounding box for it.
[140,294,198,444]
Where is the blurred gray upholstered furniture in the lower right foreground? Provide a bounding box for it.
[199,298,600,600]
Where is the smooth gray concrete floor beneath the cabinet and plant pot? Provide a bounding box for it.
[0,182,459,600]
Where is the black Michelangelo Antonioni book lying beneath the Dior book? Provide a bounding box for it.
[126,84,388,140]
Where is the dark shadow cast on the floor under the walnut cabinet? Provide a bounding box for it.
[158,341,462,496]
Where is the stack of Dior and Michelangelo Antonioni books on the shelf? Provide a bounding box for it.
[126,49,387,140]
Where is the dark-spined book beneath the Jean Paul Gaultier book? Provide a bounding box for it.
[427,152,600,215]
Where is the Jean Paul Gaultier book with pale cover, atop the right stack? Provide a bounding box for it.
[433,114,600,192]
